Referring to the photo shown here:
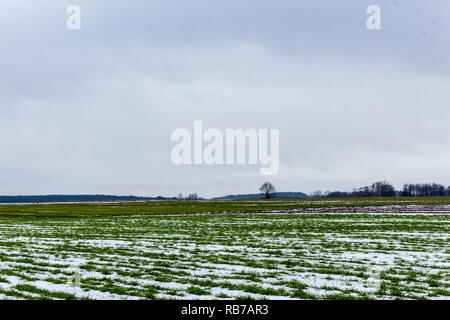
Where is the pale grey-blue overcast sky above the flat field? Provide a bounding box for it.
[0,0,450,197]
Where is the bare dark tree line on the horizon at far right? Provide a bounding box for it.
[310,181,450,198]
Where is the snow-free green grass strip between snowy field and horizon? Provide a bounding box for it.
[0,198,450,219]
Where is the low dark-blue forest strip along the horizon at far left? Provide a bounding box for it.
[0,194,176,203]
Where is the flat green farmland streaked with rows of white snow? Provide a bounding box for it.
[0,199,450,299]
